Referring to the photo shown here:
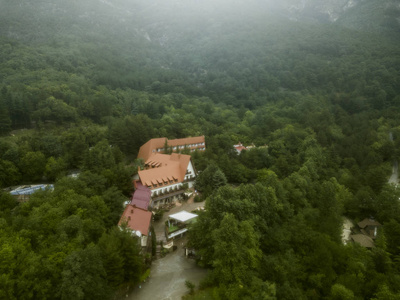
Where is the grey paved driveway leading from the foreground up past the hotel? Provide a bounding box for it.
[126,197,207,300]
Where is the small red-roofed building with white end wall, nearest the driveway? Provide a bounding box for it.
[118,204,152,247]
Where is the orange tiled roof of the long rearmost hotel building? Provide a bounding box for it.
[138,135,205,161]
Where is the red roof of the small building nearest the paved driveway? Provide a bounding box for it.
[118,204,152,235]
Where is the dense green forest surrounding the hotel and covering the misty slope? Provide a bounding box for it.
[0,0,400,300]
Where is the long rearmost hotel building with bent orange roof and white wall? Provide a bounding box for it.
[138,135,206,161]
